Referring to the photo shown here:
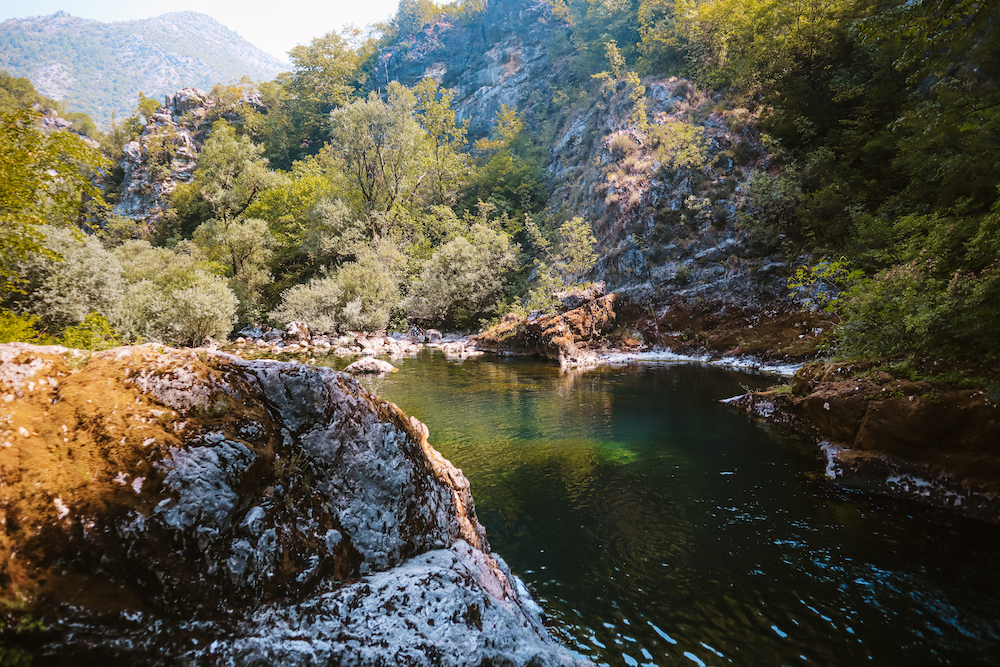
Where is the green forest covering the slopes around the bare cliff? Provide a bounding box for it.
[0,0,1000,385]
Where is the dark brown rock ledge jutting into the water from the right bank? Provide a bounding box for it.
[727,362,1000,521]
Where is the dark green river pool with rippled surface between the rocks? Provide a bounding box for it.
[342,353,1000,666]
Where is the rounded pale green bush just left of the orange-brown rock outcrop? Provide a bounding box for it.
[403,223,517,328]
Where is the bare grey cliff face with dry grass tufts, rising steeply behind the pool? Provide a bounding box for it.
[374,0,808,349]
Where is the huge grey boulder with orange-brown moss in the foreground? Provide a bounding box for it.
[0,343,575,665]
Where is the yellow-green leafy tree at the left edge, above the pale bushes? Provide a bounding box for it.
[0,110,109,287]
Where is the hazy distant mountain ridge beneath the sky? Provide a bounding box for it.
[0,12,288,127]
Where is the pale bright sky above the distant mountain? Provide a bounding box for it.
[0,0,399,62]
